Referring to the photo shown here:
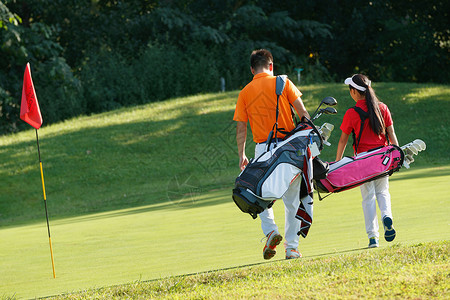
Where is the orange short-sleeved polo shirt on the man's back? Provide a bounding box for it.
[233,73,302,143]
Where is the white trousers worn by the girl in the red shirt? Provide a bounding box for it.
[360,176,392,238]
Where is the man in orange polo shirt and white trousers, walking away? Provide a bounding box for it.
[233,49,310,259]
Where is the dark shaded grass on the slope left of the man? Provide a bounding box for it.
[0,92,243,227]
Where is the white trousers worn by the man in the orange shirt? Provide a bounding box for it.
[255,143,302,248]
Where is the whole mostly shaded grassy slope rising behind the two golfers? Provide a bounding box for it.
[0,83,450,226]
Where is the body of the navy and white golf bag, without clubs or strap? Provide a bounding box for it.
[232,123,320,237]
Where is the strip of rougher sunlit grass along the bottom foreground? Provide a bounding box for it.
[46,241,450,299]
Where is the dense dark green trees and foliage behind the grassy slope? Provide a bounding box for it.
[0,0,450,133]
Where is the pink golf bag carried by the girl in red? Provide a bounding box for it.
[314,145,404,198]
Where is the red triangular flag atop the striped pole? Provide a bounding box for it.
[20,63,42,129]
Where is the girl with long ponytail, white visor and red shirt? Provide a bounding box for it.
[336,74,398,248]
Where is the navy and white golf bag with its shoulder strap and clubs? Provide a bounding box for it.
[232,75,337,237]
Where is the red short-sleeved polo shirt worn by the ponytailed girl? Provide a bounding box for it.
[340,99,394,153]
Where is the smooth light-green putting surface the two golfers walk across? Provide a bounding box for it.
[0,166,450,298]
